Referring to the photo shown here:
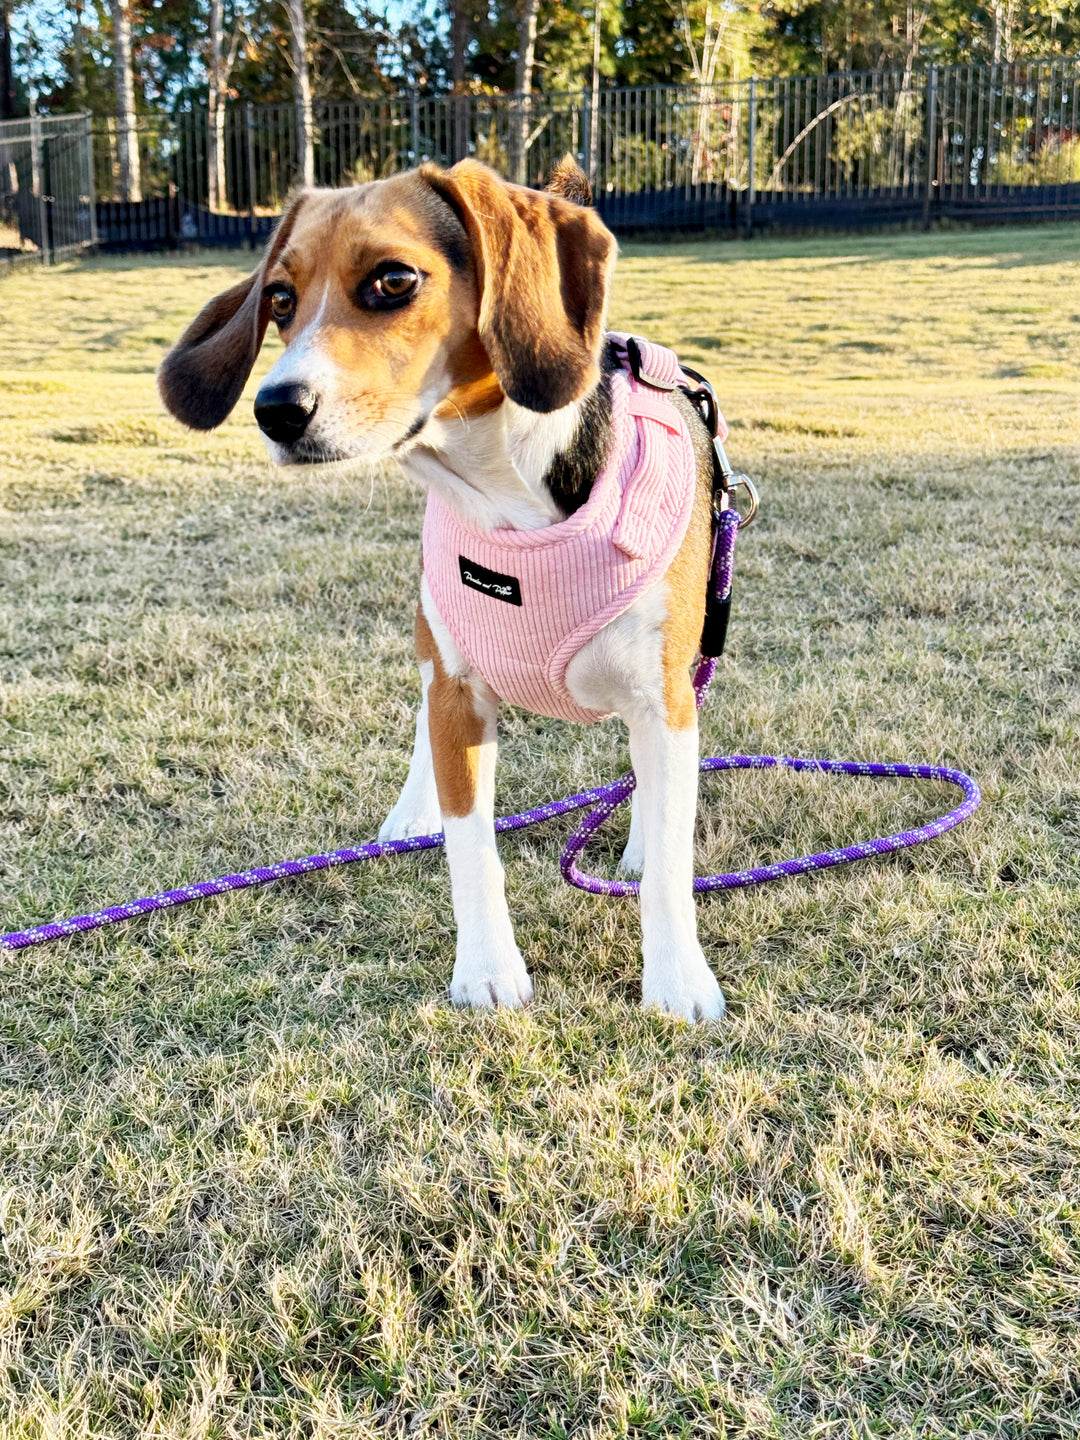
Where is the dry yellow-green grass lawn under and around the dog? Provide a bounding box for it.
[0,218,1080,1440]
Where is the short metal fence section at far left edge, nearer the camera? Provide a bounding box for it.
[0,115,96,266]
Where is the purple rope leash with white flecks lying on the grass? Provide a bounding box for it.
[0,510,981,950]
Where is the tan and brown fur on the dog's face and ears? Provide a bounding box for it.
[158,161,615,440]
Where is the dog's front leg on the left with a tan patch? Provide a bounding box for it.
[416,596,533,1008]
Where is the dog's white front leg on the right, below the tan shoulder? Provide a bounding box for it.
[626,696,724,1021]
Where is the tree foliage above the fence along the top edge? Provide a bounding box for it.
[17,0,1080,114]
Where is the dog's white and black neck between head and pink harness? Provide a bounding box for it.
[400,373,611,530]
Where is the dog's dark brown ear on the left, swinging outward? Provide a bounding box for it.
[157,192,311,431]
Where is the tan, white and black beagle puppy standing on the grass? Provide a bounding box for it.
[158,160,724,1021]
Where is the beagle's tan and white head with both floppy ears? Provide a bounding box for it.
[158,160,615,464]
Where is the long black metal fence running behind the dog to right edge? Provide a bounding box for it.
[76,59,1080,245]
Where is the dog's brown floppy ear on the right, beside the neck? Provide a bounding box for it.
[420,160,615,413]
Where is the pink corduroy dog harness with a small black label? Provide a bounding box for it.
[423,334,727,721]
